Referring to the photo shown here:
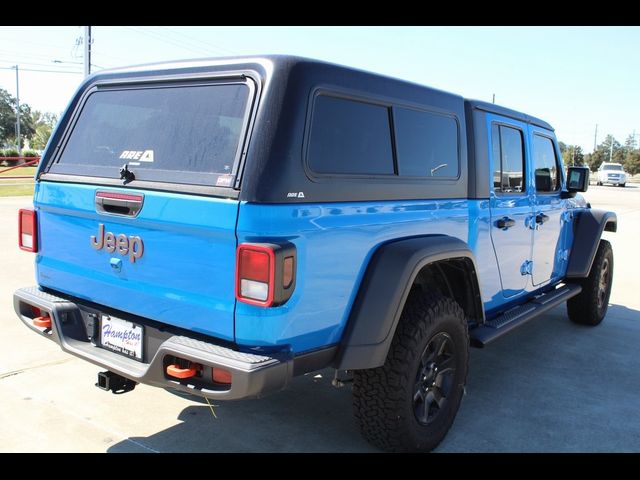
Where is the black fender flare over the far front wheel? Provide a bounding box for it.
[566,209,618,279]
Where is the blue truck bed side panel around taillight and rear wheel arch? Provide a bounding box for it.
[235,199,499,353]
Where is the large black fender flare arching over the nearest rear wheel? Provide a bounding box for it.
[334,235,484,370]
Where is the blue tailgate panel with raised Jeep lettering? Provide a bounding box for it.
[35,182,238,340]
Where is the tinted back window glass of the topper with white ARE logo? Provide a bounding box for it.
[50,83,250,186]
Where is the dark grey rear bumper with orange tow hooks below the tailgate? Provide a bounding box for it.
[13,287,293,400]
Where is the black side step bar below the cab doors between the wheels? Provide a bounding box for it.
[469,283,582,348]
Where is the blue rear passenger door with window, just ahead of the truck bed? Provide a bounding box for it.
[489,116,533,297]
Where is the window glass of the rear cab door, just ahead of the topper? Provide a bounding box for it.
[492,125,526,193]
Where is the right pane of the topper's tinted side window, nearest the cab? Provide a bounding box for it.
[394,108,459,177]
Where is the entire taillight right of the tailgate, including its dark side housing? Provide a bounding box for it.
[236,242,296,307]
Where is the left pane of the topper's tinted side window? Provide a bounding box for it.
[308,95,394,175]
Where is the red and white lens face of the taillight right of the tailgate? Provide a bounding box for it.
[236,243,275,307]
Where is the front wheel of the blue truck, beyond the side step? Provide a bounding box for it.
[567,240,613,326]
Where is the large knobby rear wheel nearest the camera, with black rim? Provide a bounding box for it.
[353,290,469,452]
